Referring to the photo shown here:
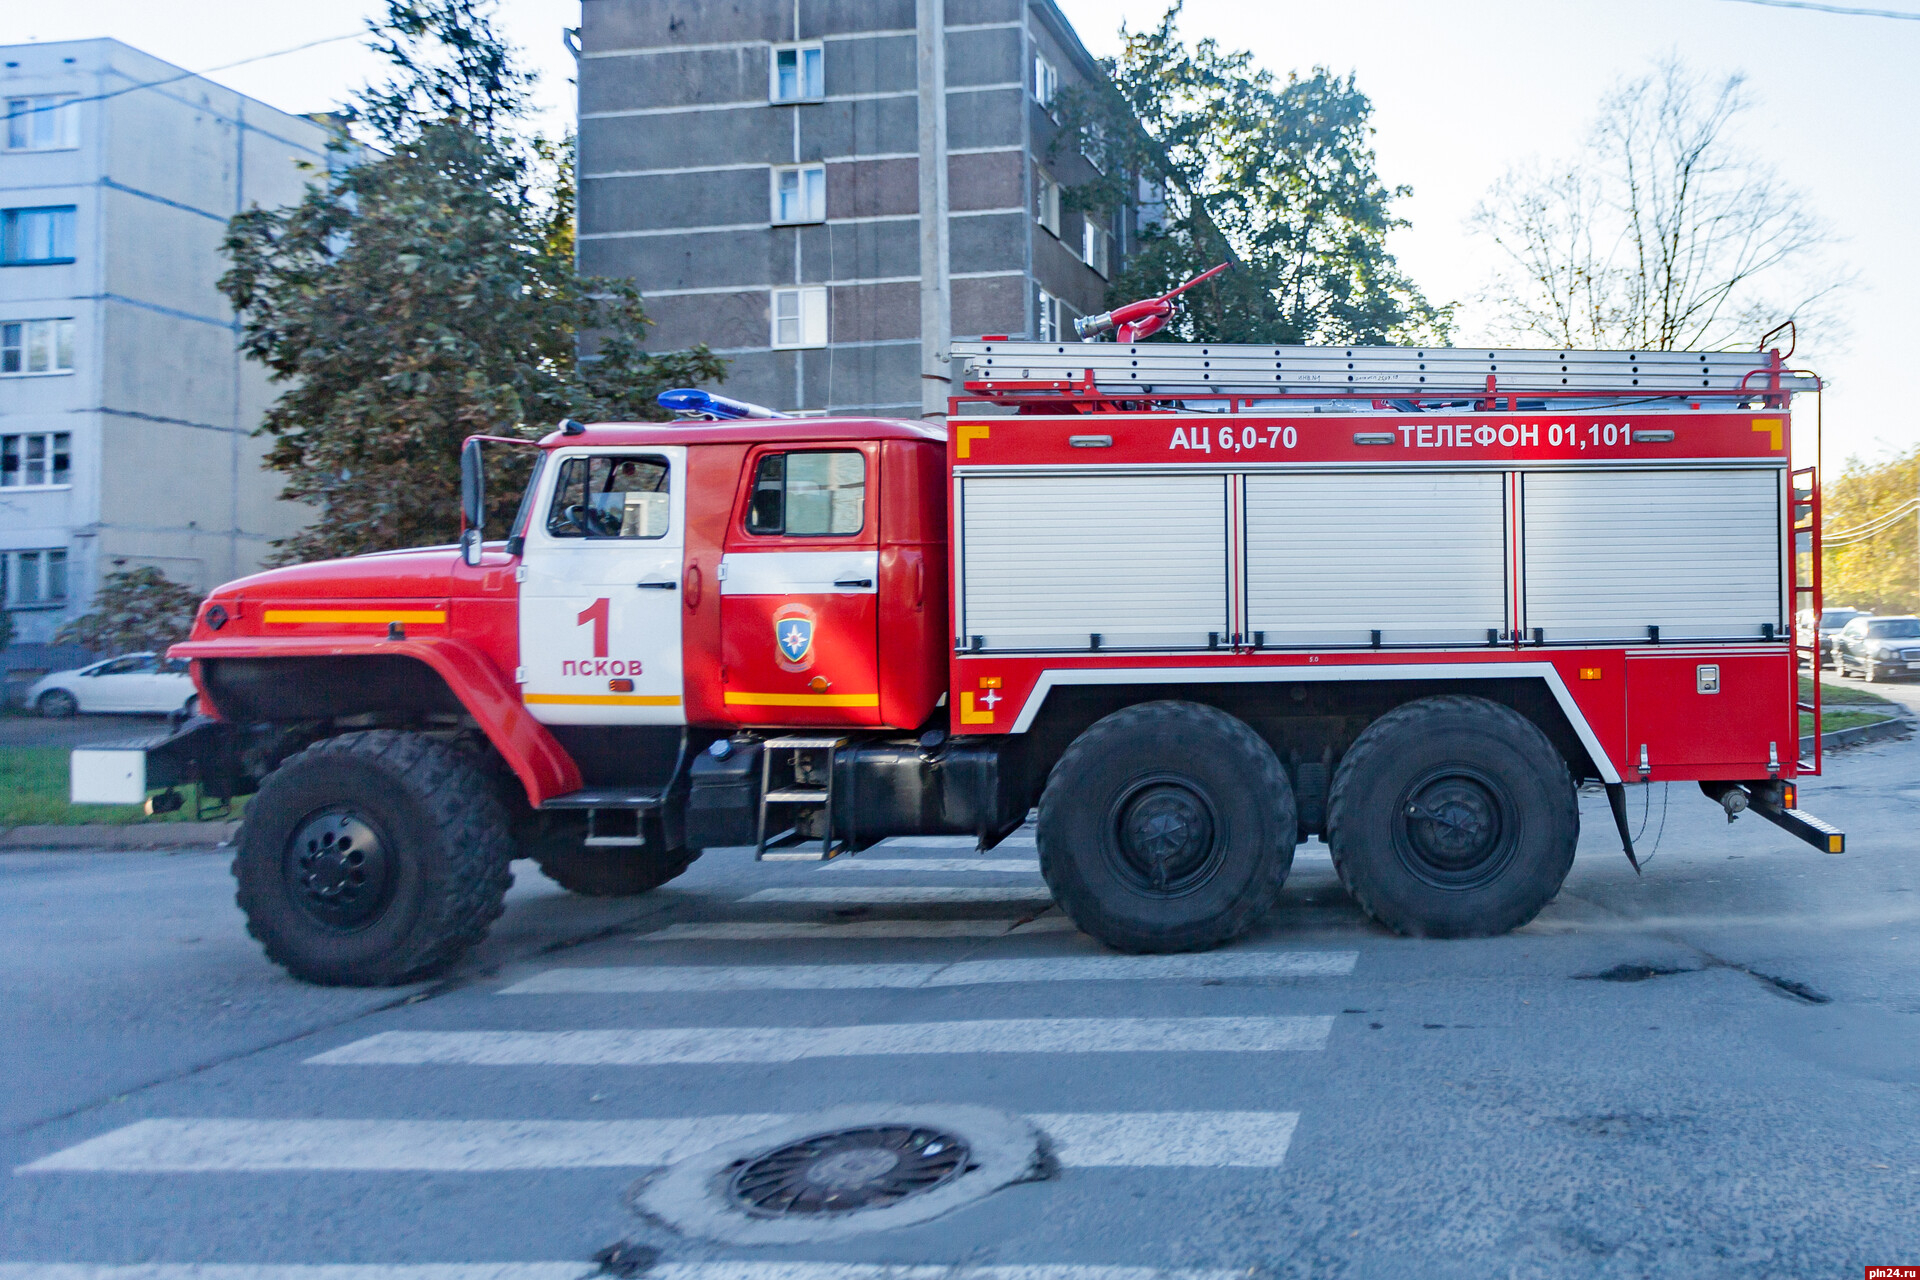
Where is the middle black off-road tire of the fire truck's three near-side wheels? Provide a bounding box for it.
[1037,702,1298,952]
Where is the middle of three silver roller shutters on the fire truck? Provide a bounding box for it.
[1246,472,1507,647]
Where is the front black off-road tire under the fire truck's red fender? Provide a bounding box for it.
[234,729,513,986]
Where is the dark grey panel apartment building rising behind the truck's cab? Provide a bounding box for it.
[578,0,1129,416]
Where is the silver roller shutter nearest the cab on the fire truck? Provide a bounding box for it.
[958,476,1227,651]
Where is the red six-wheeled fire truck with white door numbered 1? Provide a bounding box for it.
[73,338,1843,984]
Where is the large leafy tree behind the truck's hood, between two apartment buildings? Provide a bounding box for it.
[221,0,724,560]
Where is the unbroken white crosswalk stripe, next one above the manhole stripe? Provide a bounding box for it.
[307,1015,1332,1067]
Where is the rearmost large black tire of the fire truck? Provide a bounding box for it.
[1327,697,1580,938]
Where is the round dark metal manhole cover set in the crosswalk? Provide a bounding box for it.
[728,1125,968,1219]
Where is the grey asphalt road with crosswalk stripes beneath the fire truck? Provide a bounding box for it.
[0,725,1920,1280]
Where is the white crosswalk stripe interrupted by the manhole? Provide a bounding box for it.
[15,1111,1300,1174]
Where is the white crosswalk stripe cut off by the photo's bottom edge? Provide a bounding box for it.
[0,1263,1246,1280]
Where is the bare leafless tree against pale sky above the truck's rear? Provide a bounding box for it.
[1469,59,1845,351]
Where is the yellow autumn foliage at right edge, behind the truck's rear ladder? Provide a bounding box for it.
[1820,447,1920,614]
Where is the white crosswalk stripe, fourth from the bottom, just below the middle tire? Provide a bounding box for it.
[499,952,1359,996]
